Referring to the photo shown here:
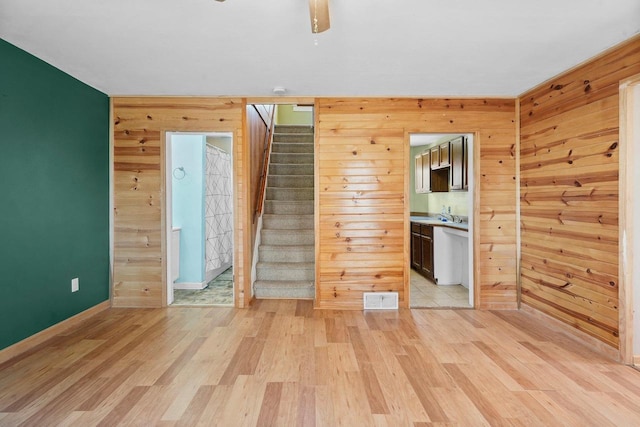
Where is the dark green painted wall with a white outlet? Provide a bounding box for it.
[0,39,109,349]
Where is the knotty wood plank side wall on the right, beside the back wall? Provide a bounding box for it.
[520,37,640,347]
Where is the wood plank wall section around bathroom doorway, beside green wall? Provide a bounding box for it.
[112,97,251,307]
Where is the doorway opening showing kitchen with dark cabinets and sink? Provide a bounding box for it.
[409,133,474,308]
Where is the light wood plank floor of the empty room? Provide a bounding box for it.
[0,301,640,427]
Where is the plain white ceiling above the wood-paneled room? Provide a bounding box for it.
[0,0,640,97]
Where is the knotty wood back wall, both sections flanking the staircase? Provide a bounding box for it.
[113,98,517,309]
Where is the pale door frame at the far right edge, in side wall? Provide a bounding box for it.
[618,74,640,365]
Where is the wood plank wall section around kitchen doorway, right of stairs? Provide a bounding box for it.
[316,99,517,309]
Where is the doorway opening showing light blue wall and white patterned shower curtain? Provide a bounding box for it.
[166,132,234,306]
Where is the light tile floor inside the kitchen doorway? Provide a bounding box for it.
[410,269,471,308]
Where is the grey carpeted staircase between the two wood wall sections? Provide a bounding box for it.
[253,125,315,299]
